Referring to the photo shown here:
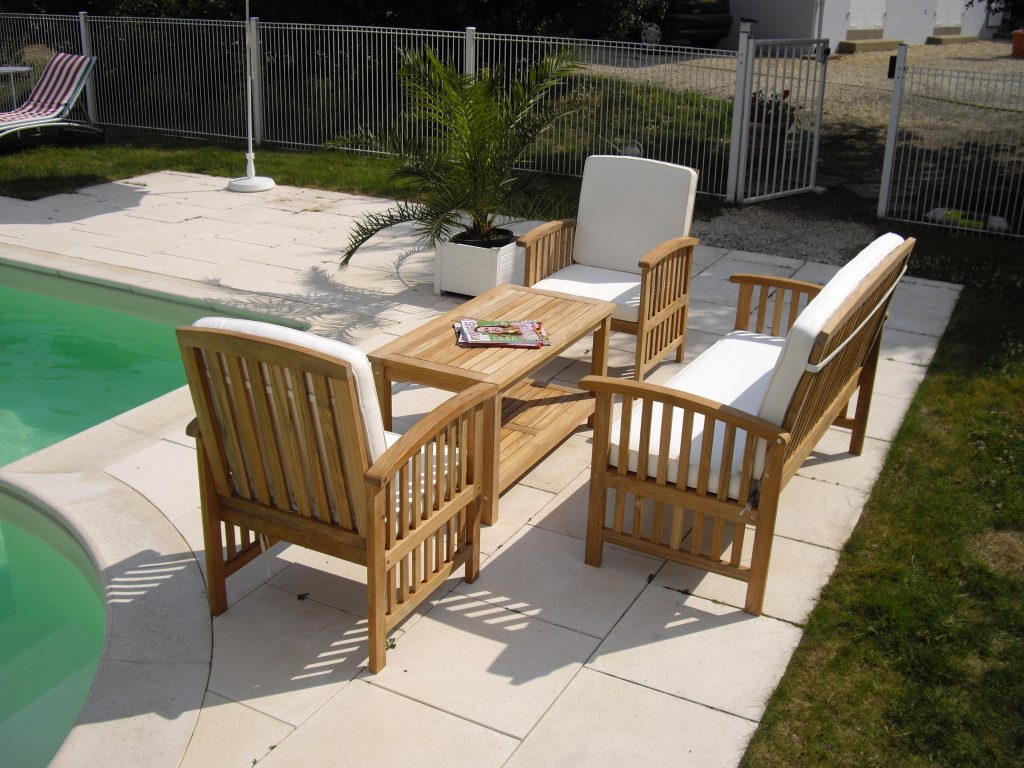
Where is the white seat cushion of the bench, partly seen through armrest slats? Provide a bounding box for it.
[611,331,784,499]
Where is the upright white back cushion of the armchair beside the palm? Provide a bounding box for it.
[572,155,697,272]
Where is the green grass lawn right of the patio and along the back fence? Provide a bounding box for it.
[0,141,1024,767]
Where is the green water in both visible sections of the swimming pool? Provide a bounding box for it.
[0,266,204,768]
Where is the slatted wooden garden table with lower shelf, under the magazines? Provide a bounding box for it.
[369,285,615,524]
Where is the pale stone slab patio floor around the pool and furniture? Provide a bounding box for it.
[0,172,958,768]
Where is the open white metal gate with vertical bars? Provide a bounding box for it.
[726,22,828,203]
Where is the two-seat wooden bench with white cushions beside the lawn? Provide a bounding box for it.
[581,233,914,614]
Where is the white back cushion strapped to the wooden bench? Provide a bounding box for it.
[758,232,903,426]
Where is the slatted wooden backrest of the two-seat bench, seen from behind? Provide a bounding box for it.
[782,239,914,471]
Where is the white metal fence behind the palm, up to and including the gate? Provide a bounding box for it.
[0,13,824,202]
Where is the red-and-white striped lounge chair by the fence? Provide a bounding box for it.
[0,53,96,137]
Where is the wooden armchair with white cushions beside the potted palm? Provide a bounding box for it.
[518,155,697,380]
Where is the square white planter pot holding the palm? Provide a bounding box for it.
[434,241,525,296]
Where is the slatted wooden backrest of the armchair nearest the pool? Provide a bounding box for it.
[178,328,370,536]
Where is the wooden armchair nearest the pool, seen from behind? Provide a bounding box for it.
[177,318,496,672]
